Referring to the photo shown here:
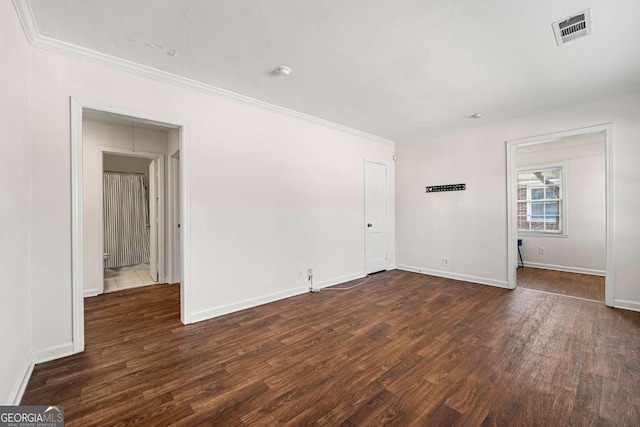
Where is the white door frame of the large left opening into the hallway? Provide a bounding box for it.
[69,96,193,354]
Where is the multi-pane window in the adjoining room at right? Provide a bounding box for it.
[518,166,564,234]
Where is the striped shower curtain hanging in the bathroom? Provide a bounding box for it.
[103,172,149,268]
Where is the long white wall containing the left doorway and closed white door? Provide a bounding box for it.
[25,36,395,349]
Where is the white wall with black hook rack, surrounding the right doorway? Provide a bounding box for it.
[396,91,640,310]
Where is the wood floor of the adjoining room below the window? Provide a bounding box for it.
[516,267,604,302]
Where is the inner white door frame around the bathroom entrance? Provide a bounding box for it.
[96,147,165,294]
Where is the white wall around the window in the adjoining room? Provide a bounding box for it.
[516,132,607,275]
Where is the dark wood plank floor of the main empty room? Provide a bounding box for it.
[22,271,640,426]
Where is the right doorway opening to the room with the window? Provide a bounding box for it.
[507,125,613,305]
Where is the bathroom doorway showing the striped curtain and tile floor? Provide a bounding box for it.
[98,151,165,293]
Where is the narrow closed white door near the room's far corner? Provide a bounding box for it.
[364,161,387,274]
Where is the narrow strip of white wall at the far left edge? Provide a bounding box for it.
[0,2,33,405]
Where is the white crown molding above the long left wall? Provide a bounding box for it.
[13,0,395,146]
